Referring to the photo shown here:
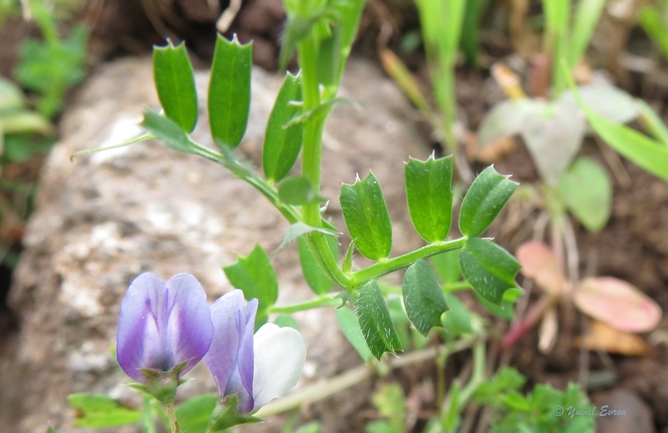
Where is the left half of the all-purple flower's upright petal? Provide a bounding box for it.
[116,273,171,382]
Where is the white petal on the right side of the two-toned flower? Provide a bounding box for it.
[253,323,306,410]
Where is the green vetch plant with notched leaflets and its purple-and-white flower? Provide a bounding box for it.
[68,0,520,426]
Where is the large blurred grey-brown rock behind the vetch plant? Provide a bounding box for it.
[0,58,428,433]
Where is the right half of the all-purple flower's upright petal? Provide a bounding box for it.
[164,274,213,374]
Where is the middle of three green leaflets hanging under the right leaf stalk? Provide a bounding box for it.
[402,259,448,336]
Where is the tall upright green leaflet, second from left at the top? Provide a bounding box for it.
[209,35,253,149]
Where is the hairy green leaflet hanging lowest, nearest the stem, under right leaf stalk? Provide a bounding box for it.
[355,280,401,360]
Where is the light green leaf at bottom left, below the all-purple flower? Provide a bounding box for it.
[67,392,141,428]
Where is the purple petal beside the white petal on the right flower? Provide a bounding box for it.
[204,290,257,413]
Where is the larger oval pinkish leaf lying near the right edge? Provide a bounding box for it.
[573,277,661,332]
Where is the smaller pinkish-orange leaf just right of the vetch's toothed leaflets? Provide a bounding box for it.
[516,241,570,295]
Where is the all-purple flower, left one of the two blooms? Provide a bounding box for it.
[116,273,213,383]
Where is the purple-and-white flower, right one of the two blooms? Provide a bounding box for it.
[204,290,306,414]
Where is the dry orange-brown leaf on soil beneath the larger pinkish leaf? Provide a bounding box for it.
[575,321,650,356]
